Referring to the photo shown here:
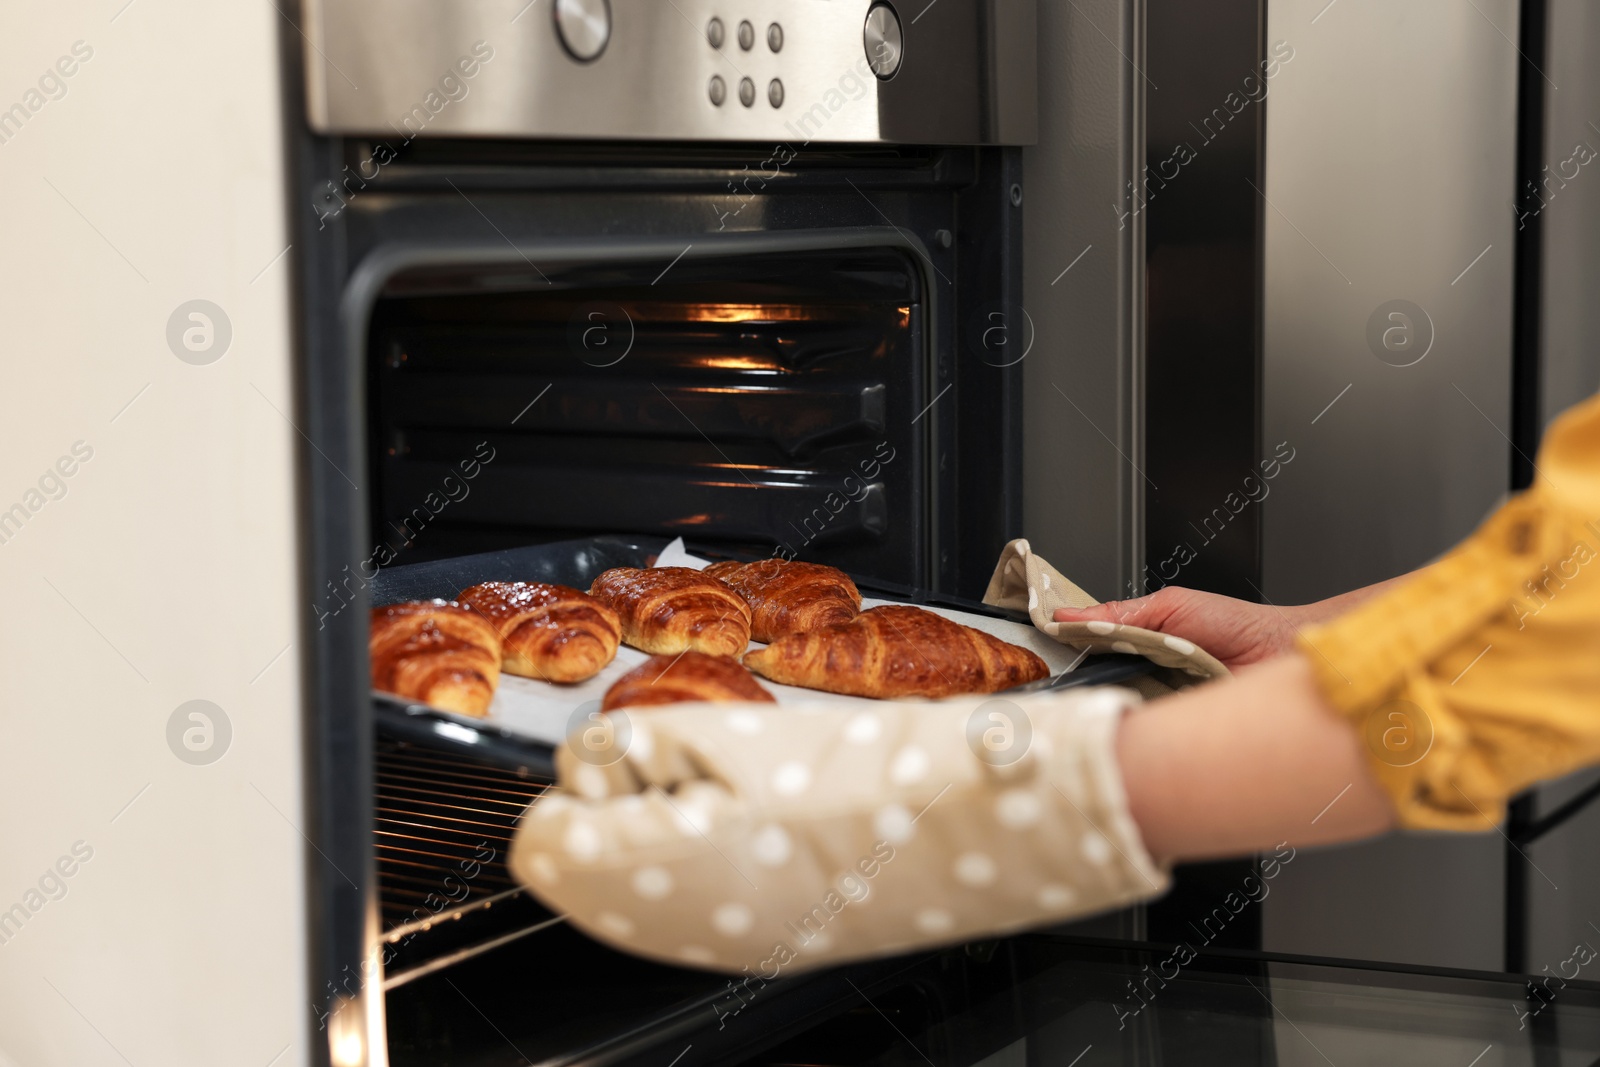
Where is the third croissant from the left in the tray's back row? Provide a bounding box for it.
[589,566,750,656]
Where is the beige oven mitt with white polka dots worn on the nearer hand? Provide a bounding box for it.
[510,688,1168,979]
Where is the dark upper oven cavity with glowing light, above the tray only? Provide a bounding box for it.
[368,246,931,585]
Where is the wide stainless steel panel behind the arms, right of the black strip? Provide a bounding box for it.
[1262,0,1517,966]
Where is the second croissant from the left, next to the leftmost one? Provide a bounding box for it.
[456,582,622,681]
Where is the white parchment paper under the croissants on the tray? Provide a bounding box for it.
[380,541,1082,745]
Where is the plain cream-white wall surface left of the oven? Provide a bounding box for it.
[0,0,312,1067]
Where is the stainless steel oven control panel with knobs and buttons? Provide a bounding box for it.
[304,0,1037,144]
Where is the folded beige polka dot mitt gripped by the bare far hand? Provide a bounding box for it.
[984,537,1229,685]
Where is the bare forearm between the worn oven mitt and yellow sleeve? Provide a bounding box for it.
[1117,653,1395,861]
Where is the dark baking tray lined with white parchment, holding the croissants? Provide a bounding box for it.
[371,536,1155,777]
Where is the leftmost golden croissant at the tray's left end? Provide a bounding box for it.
[366,600,501,715]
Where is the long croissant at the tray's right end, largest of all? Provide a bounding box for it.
[744,605,1050,697]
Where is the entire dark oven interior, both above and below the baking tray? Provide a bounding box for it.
[365,239,934,1064]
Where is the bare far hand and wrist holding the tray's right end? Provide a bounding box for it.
[1056,585,1309,670]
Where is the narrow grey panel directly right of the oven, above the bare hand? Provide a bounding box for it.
[1022,0,1144,600]
